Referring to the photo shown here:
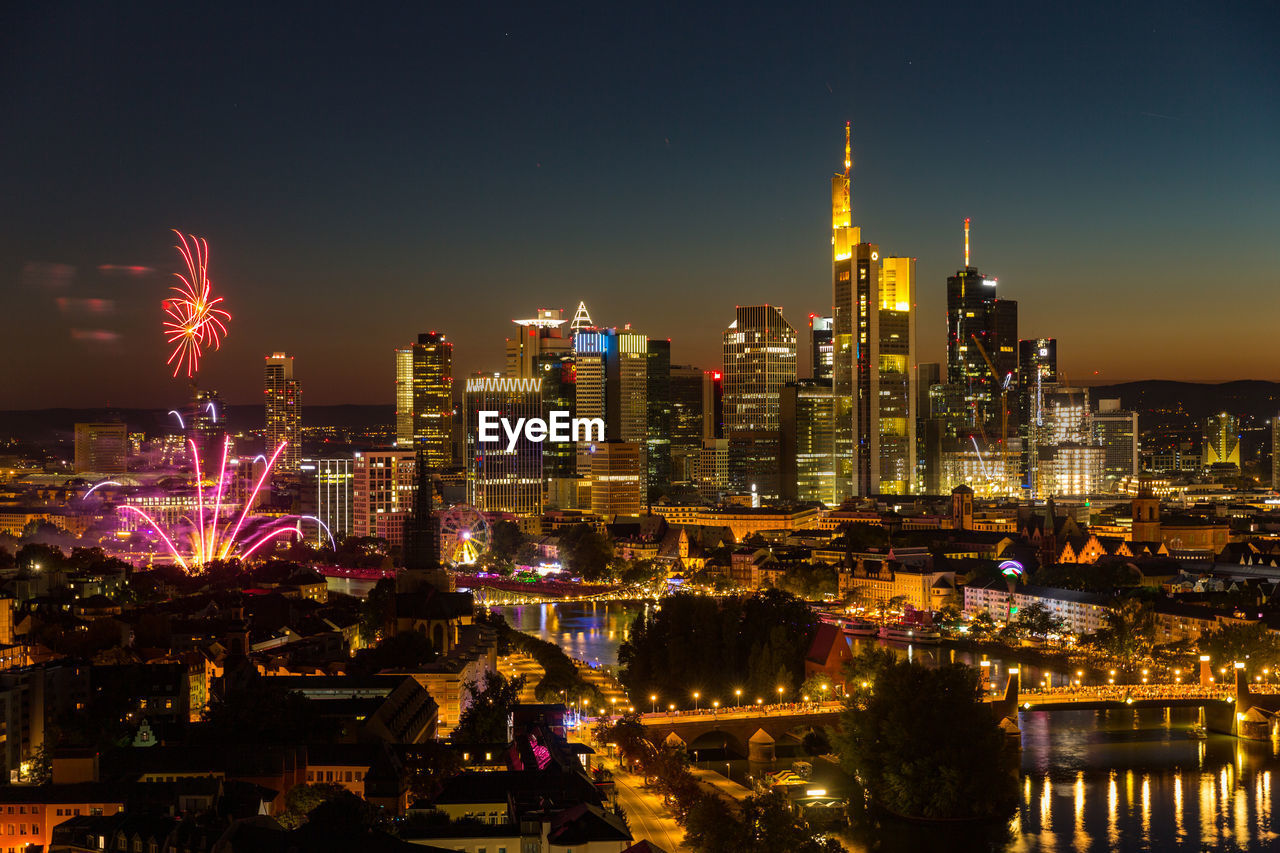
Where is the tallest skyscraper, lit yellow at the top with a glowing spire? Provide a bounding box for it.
[831,124,916,502]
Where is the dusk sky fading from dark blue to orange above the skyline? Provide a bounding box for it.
[0,0,1280,409]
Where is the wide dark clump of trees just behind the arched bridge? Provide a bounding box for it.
[618,589,818,707]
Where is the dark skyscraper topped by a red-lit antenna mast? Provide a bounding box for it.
[947,219,1018,425]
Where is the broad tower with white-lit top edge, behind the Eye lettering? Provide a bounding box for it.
[466,377,550,516]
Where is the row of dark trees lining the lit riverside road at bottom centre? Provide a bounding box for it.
[594,716,844,853]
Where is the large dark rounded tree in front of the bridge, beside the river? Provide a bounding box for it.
[837,661,1018,820]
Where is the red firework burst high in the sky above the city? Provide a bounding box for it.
[163,231,232,377]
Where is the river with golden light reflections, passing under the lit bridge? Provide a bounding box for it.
[497,602,1280,853]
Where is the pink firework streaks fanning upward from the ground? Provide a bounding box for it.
[108,438,337,574]
